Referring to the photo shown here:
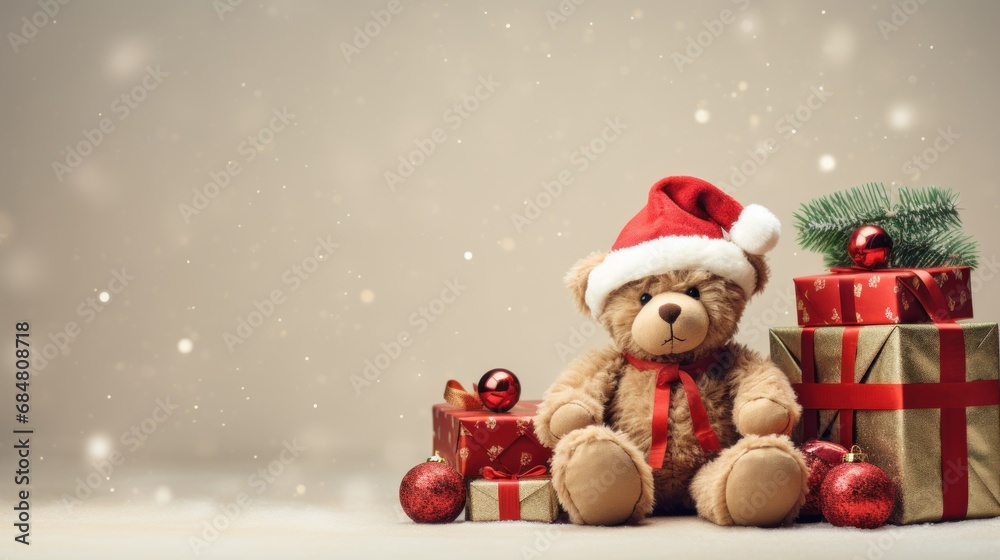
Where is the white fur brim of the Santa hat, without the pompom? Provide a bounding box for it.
[584,236,757,319]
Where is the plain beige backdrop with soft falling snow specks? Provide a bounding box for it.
[0,1,1000,524]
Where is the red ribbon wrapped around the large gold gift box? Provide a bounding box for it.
[793,322,1000,520]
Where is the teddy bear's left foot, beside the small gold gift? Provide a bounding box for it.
[552,426,653,525]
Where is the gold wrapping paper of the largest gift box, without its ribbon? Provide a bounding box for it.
[770,323,1000,524]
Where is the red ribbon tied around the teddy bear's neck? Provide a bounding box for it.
[623,354,722,469]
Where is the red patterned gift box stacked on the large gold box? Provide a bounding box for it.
[793,266,972,327]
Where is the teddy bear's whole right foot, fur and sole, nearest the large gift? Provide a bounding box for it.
[691,436,809,527]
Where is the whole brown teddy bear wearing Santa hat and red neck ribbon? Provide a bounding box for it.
[535,177,808,527]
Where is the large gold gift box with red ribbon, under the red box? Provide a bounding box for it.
[770,323,1000,524]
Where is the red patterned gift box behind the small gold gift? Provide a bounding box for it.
[432,401,552,478]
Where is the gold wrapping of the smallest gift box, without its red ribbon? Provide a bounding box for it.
[465,477,559,523]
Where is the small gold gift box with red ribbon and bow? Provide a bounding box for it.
[465,467,559,523]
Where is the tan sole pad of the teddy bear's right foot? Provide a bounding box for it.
[726,447,802,527]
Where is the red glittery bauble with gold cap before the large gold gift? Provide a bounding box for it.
[820,445,896,529]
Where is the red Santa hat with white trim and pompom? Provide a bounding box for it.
[584,176,781,318]
